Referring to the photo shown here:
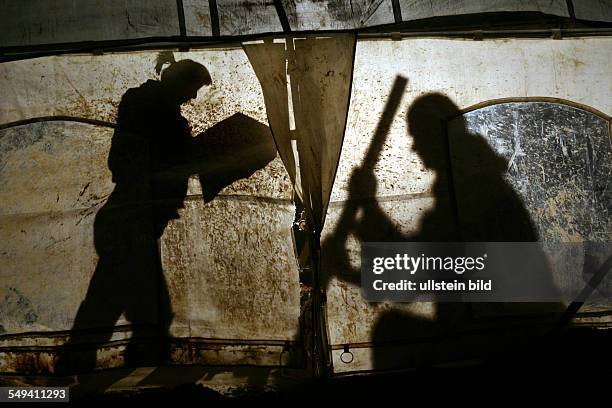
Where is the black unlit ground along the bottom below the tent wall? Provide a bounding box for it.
[2,329,612,407]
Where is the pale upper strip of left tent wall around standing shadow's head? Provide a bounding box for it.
[0,48,266,129]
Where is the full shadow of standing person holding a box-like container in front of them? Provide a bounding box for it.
[55,53,276,385]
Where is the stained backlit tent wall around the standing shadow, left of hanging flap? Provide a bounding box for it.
[0,48,300,371]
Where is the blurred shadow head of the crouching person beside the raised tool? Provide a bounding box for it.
[408,93,459,170]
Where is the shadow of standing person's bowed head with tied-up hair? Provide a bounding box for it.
[155,53,212,105]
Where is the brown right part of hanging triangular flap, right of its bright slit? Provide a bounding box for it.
[291,35,355,232]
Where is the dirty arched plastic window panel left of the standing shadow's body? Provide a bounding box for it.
[0,122,139,333]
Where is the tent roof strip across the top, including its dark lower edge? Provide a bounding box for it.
[0,0,612,62]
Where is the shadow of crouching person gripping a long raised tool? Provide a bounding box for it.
[323,87,560,369]
